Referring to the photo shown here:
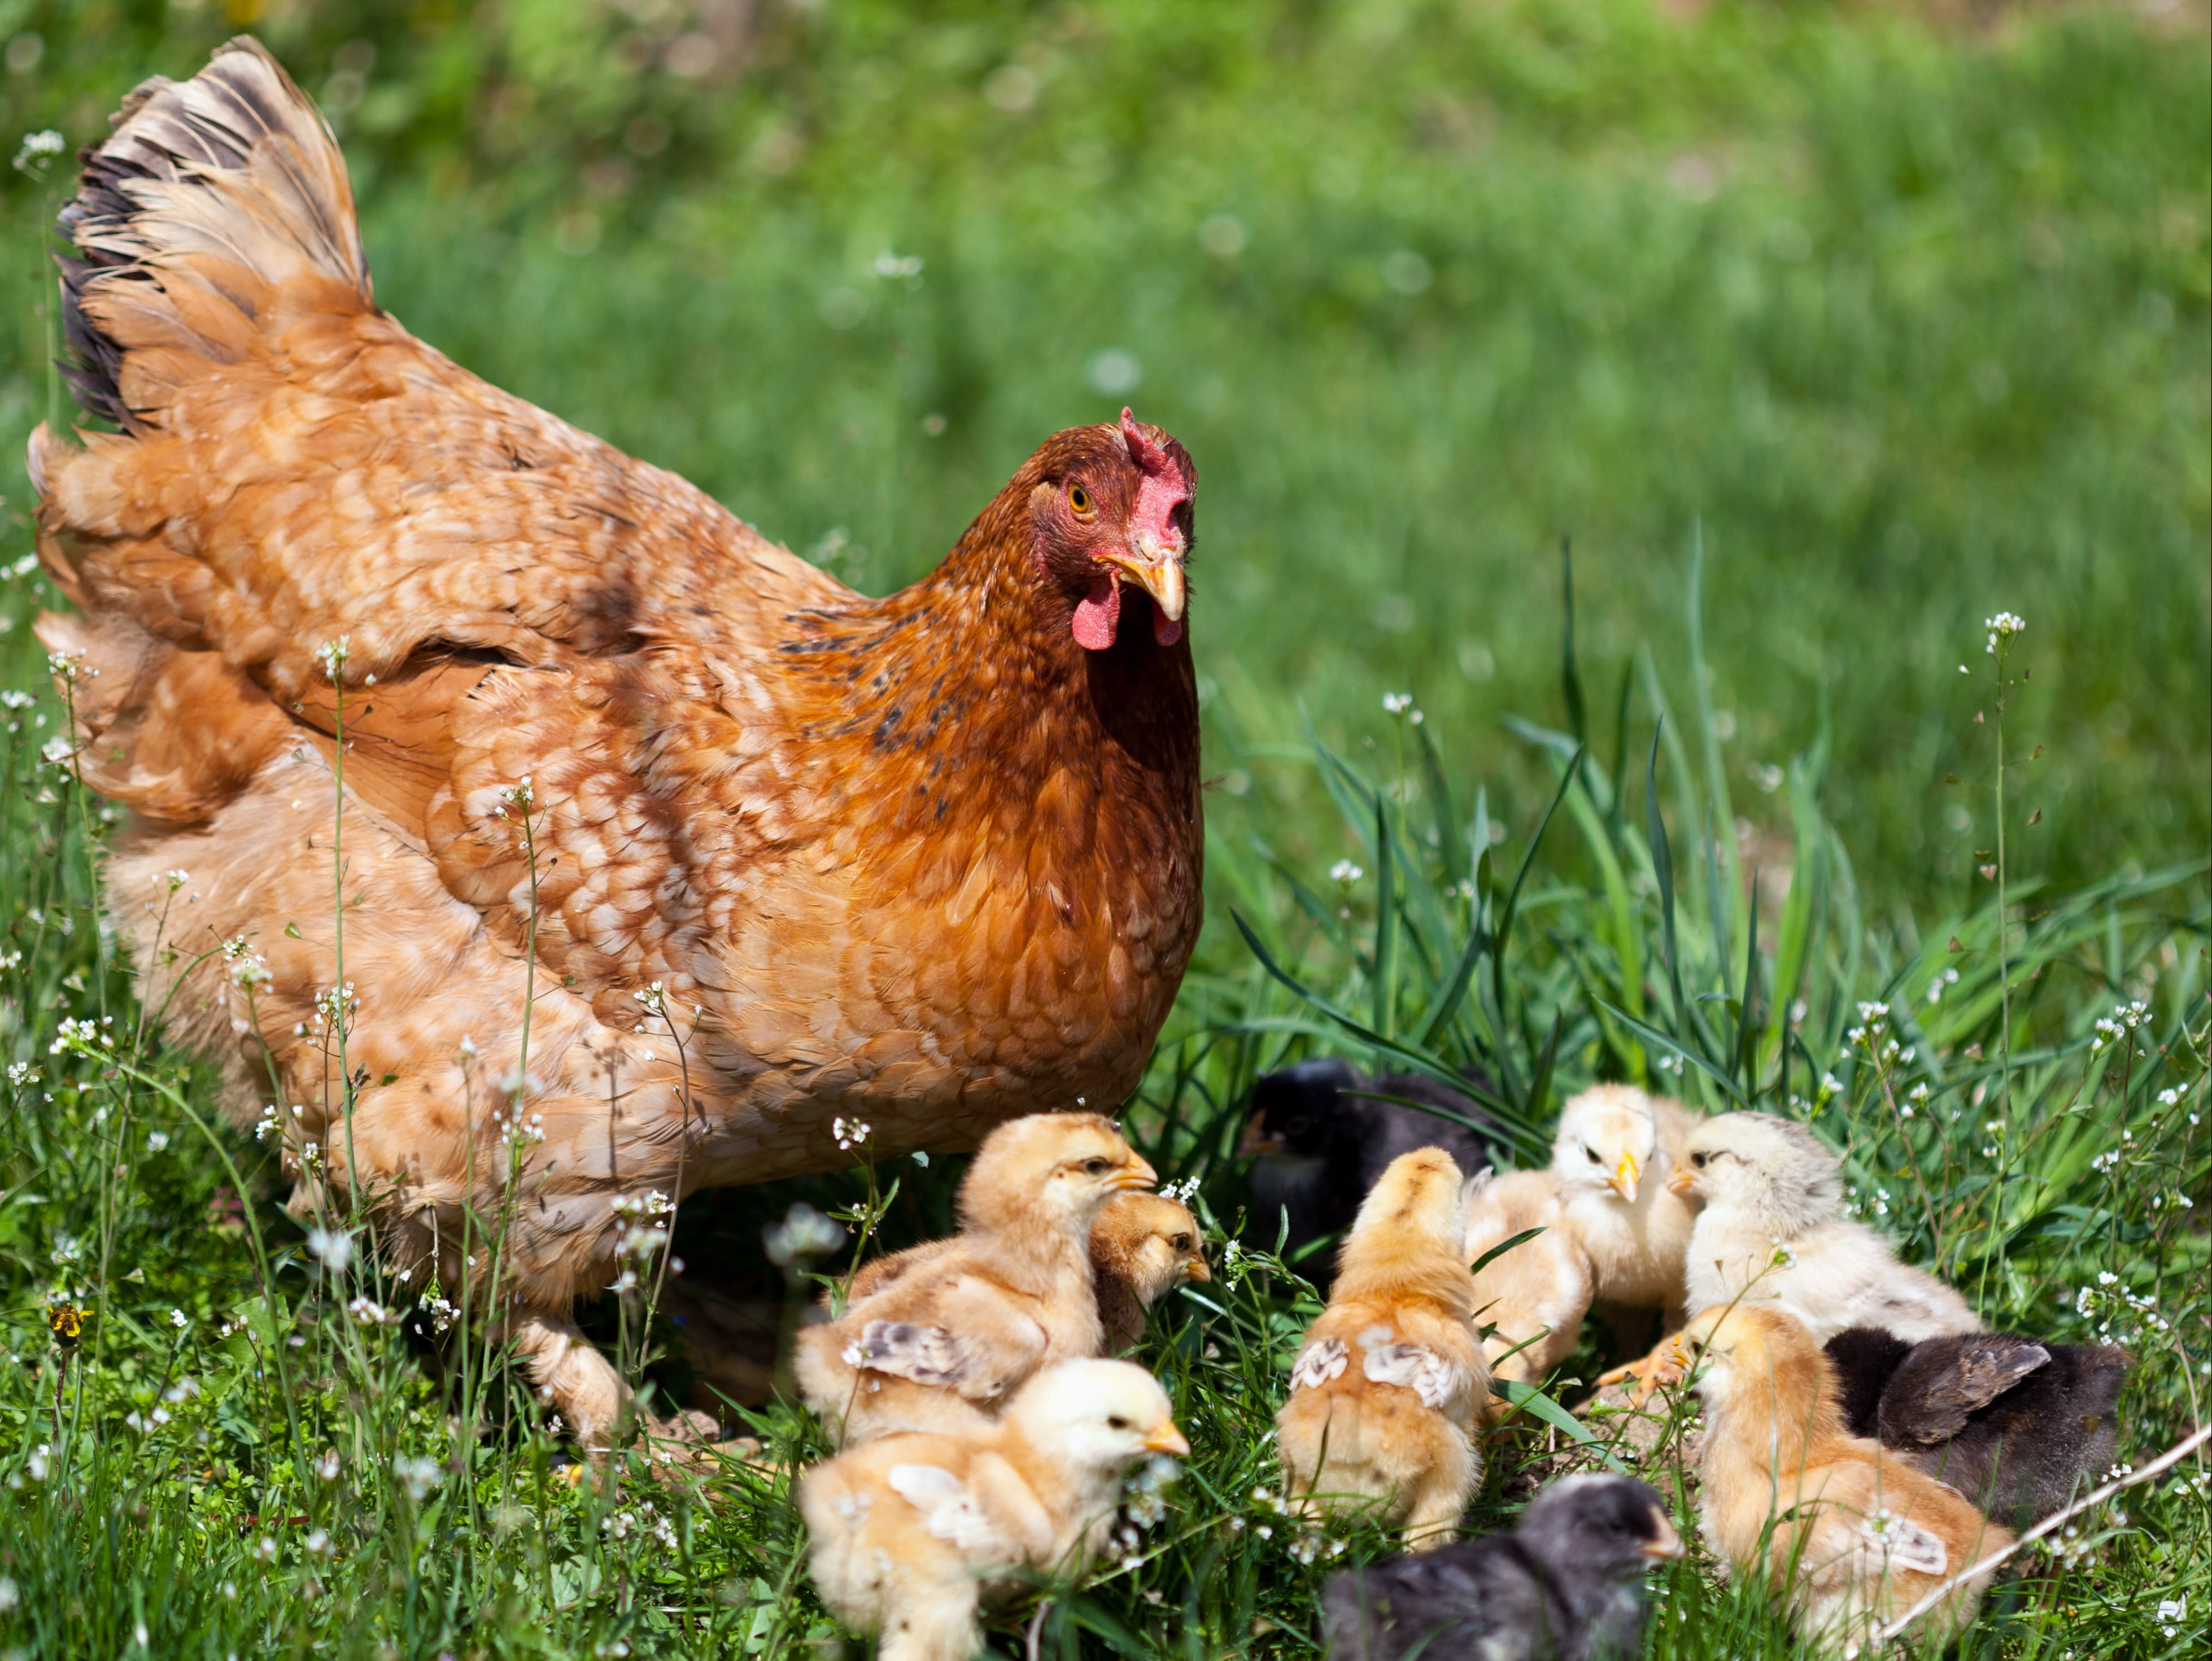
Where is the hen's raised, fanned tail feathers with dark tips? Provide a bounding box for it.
[58,38,374,434]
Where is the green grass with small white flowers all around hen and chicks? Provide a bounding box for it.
[0,0,2212,1661]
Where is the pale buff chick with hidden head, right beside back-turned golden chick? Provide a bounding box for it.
[1467,1170,1593,1418]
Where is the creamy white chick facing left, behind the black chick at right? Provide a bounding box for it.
[1672,1113,1982,1342]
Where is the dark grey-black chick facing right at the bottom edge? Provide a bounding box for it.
[1323,1475,1681,1661]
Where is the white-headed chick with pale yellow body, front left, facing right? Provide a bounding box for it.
[799,1360,1190,1661]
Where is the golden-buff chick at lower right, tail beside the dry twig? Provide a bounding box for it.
[1674,1303,2013,1652]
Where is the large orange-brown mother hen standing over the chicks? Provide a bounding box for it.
[31,40,1201,1437]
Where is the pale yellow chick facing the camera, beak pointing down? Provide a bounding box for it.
[1551,1084,1696,1327]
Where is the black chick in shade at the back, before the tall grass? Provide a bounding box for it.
[1237,1055,1506,1292]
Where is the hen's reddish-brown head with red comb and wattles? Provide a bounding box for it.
[1028,409,1199,652]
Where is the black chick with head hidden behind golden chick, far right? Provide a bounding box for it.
[1827,1327,2130,1528]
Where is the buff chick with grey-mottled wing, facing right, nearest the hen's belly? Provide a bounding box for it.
[792,1113,1155,1446]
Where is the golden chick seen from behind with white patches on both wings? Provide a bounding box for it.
[1274,1148,1491,1550]
